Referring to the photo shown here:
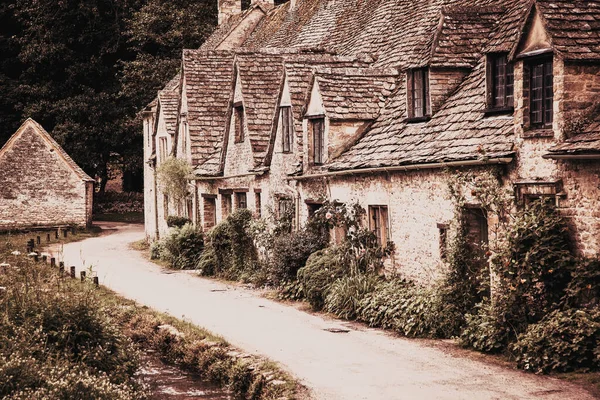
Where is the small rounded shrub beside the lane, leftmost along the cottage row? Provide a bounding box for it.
[161,224,204,269]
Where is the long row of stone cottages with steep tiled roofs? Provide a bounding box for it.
[144,0,600,282]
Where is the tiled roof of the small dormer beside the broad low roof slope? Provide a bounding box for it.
[315,68,398,120]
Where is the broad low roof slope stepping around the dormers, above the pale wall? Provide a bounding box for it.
[330,59,514,170]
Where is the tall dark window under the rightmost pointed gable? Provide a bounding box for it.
[529,59,554,128]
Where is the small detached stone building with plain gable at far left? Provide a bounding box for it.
[0,118,94,230]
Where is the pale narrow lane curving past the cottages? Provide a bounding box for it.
[58,223,593,400]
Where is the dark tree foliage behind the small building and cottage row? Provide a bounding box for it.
[0,0,216,190]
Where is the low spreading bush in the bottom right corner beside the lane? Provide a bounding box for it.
[512,309,600,373]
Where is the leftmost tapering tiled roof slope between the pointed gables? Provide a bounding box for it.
[183,50,234,175]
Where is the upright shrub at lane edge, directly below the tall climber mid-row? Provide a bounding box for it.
[298,249,349,311]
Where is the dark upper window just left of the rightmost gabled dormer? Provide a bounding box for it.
[486,54,515,110]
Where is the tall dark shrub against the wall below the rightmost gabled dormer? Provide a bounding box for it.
[494,201,576,328]
